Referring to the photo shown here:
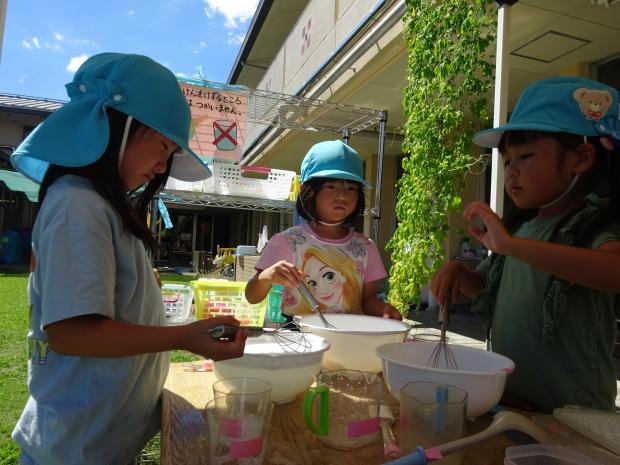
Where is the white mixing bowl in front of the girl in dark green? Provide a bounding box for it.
[377,341,515,419]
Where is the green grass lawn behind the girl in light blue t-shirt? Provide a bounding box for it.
[0,269,200,465]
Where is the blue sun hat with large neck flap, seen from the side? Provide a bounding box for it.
[11,53,211,184]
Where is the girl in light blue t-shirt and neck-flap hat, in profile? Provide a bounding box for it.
[11,53,247,465]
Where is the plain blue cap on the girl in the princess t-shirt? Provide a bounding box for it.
[300,140,370,187]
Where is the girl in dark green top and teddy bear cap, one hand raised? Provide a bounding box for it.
[431,77,620,411]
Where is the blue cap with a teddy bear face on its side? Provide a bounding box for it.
[474,77,620,147]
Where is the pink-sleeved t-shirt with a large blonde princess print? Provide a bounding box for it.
[255,225,387,316]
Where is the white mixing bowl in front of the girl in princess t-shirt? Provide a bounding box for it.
[295,313,409,373]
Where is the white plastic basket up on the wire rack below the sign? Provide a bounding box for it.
[204,162,296,200]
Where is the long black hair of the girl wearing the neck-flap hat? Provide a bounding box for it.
[39,108,174,252]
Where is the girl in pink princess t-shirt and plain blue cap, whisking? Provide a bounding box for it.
[245,140,401,319]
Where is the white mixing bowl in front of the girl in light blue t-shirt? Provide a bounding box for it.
[213,332,329,403]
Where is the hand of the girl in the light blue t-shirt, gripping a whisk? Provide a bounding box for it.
[182,316,249,361]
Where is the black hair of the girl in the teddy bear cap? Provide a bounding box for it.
[498,131,620,234]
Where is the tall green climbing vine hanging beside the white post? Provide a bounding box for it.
[387,0,495,313]
